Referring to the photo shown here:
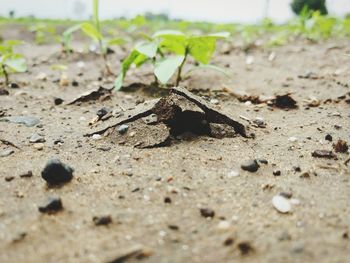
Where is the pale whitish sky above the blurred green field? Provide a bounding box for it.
[0,0,350,23]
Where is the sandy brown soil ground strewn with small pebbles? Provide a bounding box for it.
[0,27,350,262]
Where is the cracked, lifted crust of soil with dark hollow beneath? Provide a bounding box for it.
[86,87,250,148]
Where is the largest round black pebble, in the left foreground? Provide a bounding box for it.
[41,159,74,185]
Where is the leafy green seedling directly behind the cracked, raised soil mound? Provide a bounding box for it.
[115,30,229,90]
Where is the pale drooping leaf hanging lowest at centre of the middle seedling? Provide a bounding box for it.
[154,56,185,84]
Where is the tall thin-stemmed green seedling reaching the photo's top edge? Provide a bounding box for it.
[62,0,123,74]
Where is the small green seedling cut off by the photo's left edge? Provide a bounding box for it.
[0,40,27,86]
